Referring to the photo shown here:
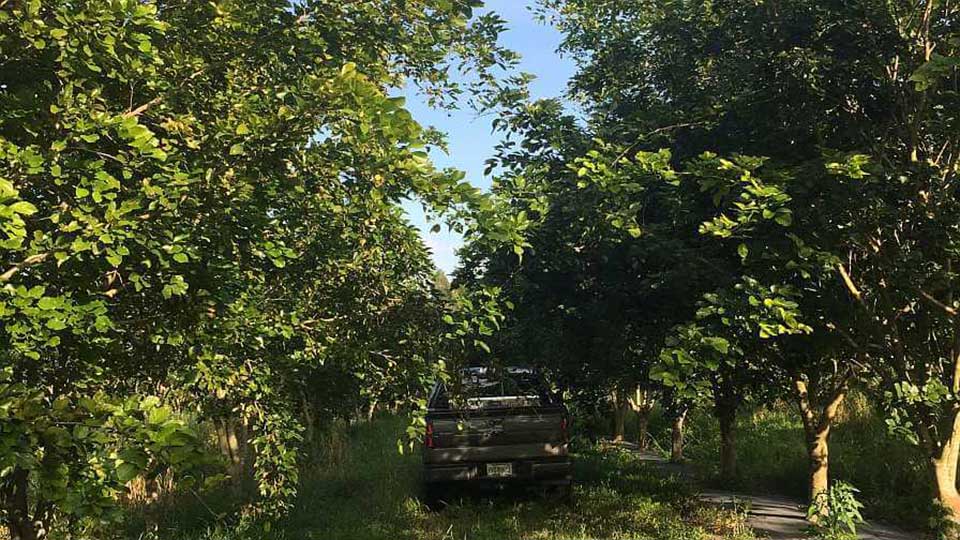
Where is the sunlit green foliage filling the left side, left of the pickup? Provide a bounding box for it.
[0,0,524,538]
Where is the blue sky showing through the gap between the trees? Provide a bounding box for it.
[404,0,575,275]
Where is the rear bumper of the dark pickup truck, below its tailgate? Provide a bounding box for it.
[423,459,573,485]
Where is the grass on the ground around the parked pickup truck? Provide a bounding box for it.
[127,417,753,540]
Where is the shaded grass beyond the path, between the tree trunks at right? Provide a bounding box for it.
[628,395,934,528]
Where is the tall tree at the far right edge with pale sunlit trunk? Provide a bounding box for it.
[546,0,960,515]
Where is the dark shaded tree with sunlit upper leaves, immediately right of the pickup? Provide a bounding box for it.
[458,101,718,439]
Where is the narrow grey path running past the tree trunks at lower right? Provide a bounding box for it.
[617,443,922,540]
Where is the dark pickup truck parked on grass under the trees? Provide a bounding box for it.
[423,367,572,508]
